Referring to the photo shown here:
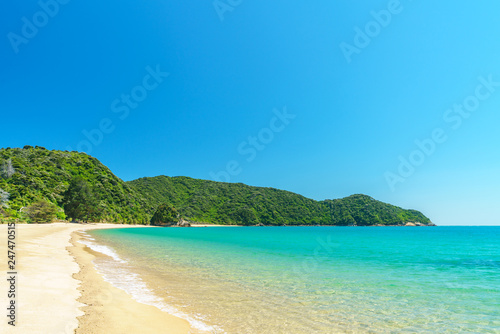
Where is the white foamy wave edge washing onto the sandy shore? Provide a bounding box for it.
[80,239,219,333]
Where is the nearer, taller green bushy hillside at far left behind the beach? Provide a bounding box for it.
[0,146,150,224]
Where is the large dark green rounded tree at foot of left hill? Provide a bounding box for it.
[62,177,102,222]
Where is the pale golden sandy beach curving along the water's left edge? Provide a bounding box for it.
[0,223,190,334]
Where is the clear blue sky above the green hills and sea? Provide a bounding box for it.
[0,0,500,225]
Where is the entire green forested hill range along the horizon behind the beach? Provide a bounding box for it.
[0,146,434,226]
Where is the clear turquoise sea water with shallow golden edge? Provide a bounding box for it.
[87,227,500,333]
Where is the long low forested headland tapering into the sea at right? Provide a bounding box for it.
[127,176,432,226]
